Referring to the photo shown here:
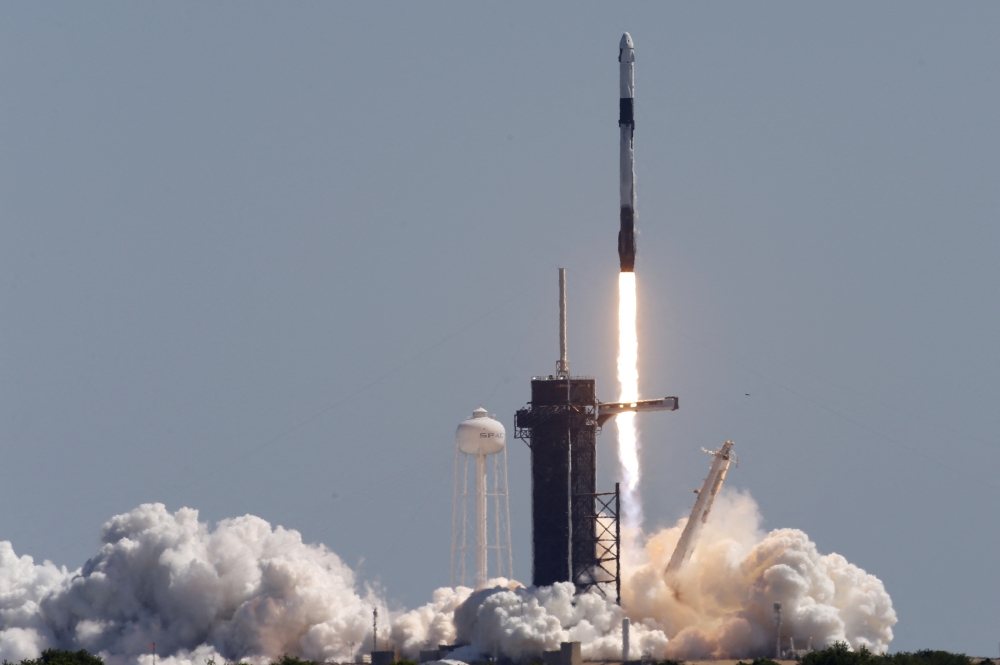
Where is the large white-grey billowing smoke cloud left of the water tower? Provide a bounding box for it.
[0,504,389,665]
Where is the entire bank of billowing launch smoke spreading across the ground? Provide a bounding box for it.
[0,491,896,665]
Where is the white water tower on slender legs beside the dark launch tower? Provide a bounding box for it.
[451,407,514,589]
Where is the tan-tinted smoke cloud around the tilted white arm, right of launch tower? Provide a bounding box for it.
[622,490,896,659]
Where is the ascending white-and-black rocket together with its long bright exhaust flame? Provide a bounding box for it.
[615,32,642,533]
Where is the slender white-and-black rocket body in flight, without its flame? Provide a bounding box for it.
[618,32,635,272]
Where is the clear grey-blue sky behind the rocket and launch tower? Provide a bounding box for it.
[0,2,1000,656]
